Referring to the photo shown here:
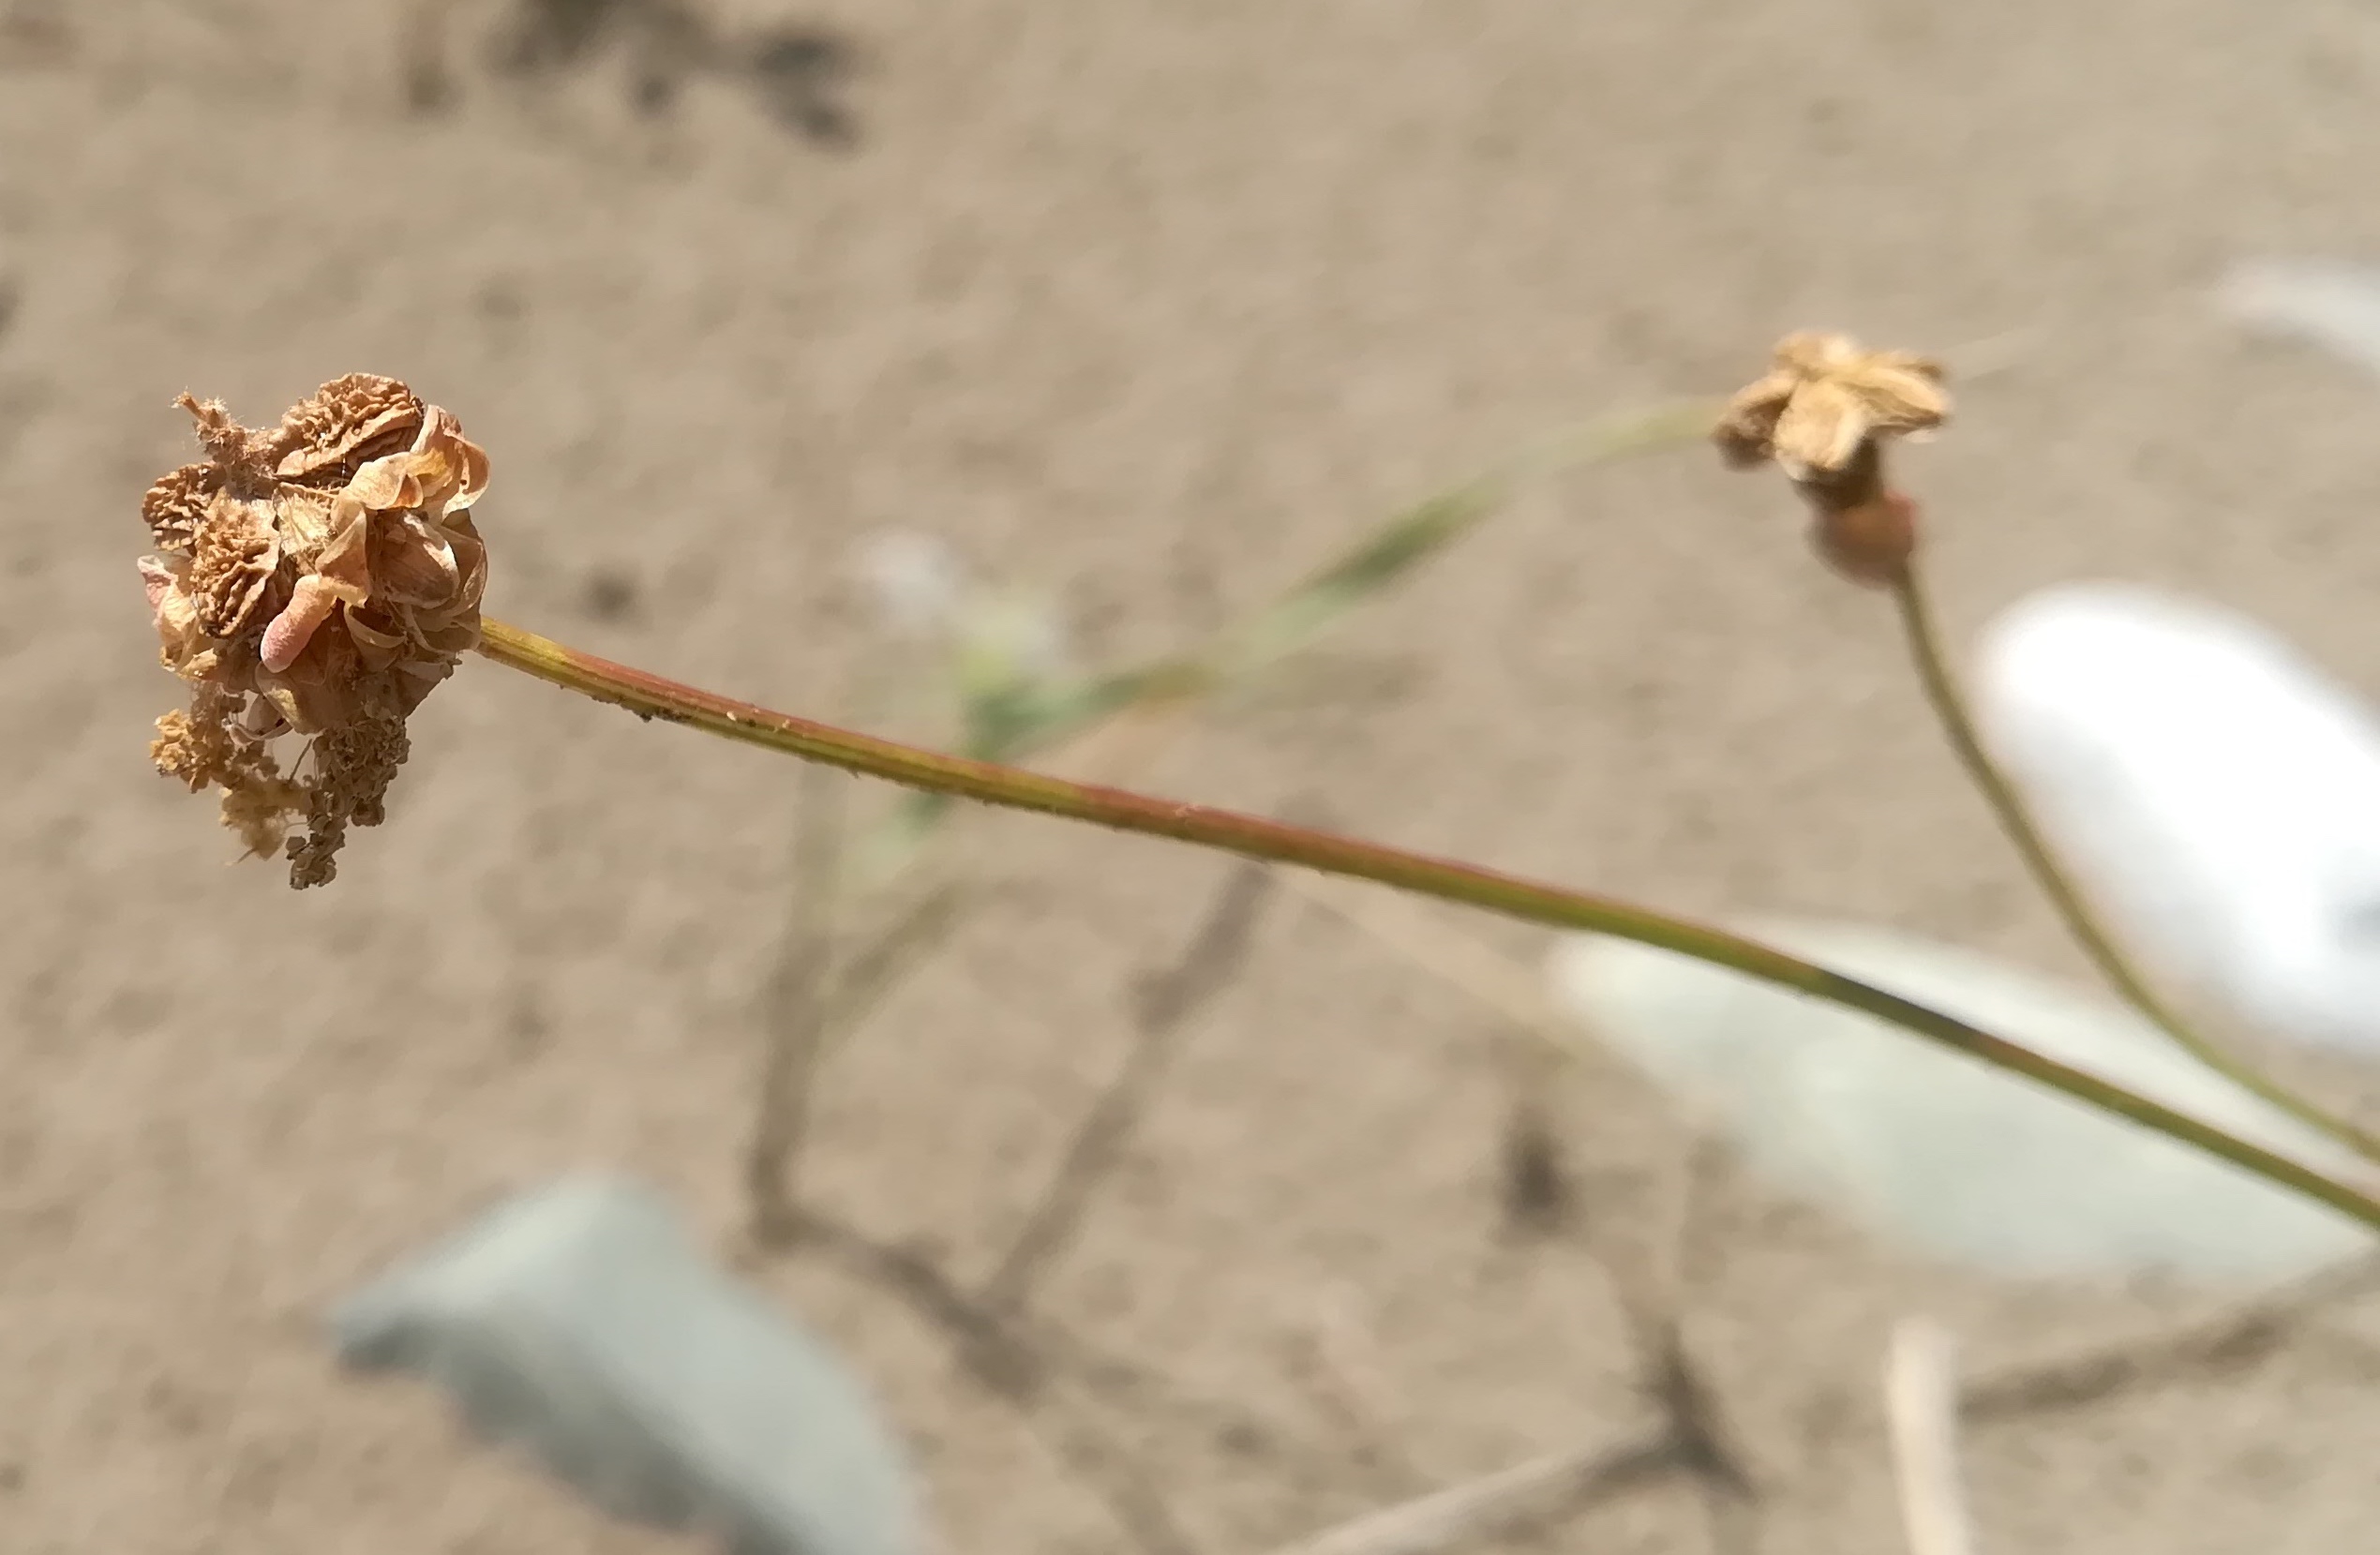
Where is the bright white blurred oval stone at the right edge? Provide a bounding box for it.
[1975,583,2380,1053]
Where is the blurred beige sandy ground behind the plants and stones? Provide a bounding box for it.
[13,0,2380,1555]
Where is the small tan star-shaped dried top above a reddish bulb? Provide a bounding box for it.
[1712,331,1949,481]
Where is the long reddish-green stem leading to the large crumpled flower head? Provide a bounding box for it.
[481,621,2380,1229]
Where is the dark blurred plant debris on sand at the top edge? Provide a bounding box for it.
[490,0,860,148]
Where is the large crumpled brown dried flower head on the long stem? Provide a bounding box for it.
[141,374,487,889]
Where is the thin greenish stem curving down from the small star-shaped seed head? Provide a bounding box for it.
[1893,564,2380,1159]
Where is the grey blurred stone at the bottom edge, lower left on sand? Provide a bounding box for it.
[333,1176,926,1555]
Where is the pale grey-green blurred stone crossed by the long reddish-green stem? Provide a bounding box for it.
[1547,920,2373,1288]
